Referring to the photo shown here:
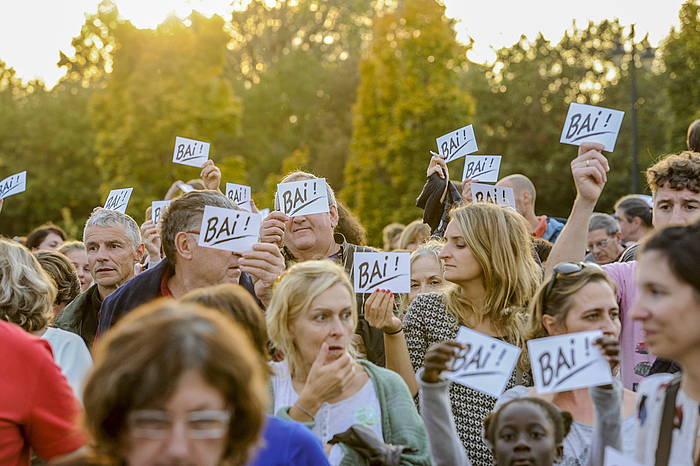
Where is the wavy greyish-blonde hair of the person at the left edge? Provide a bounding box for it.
[0,238,57,332]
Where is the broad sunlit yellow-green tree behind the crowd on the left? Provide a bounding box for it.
[91,12,244,218]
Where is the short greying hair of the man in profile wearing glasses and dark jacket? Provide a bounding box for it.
[160,190,241,265]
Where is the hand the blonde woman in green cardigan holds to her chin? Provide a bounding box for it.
[298,342,356,414]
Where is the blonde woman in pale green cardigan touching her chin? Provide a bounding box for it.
[266,260,431,465]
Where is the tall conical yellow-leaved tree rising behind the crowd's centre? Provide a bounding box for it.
[341,0,474,248]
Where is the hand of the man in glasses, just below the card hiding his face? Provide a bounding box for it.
[238,243,285,306]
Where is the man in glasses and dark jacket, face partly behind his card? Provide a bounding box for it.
[98,190,284,335]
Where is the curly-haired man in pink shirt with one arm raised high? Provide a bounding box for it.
[546,143,700,390]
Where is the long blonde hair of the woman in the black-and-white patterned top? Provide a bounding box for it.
[445,202,542,347]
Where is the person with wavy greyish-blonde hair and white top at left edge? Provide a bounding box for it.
[0,238,92,399]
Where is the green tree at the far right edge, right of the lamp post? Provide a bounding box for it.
[662,0,700,148]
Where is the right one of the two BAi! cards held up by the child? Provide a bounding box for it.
[527,330,612,393]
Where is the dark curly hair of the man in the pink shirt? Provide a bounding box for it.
[647,151,700,193]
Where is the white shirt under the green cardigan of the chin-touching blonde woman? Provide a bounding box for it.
[272,361,384,465]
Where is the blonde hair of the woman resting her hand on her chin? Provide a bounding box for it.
[265,260,357,374]
